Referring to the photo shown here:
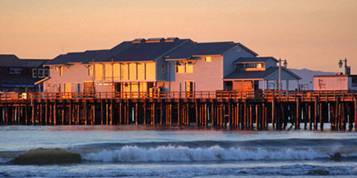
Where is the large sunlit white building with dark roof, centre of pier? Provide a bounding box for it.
[44,38,257,92]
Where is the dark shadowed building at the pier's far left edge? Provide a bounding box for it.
[0,55,48,92]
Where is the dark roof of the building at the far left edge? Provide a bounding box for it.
[0,54,48,67]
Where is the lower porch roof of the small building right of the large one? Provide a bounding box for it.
[224,67,301,80]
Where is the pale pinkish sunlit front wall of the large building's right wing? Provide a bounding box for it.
[170,56,223,91]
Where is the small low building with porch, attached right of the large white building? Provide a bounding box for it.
[224,57,301,92]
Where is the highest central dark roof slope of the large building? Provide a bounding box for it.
[110,39,192,61]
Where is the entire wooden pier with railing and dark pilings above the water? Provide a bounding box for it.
[0,91,357,131]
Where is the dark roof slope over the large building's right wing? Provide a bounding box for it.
[166,42,248,59]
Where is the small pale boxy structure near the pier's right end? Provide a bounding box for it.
[313,76,349,91]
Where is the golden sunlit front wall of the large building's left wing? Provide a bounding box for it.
[44,61,157,92]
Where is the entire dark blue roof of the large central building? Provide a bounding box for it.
[47,38,256,65]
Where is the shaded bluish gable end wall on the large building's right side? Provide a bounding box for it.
[223,46,255,76]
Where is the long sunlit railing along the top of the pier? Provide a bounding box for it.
[0,90,357,101]
